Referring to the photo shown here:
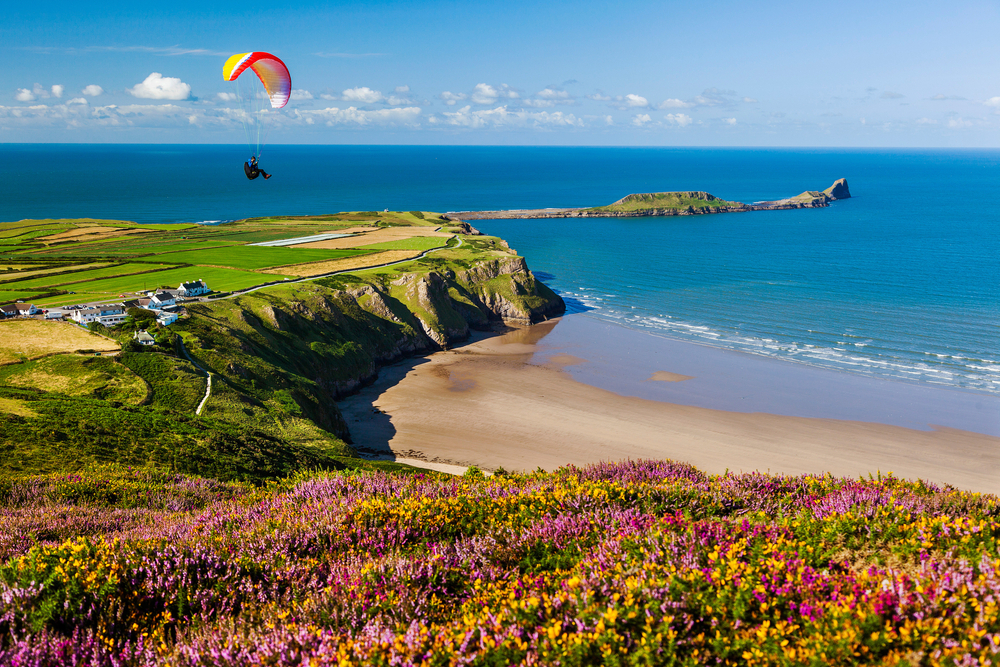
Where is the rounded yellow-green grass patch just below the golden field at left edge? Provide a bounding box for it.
[0,355,146,405]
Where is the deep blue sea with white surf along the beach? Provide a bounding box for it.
[0,144,1000,404]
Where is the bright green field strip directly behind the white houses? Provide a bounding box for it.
[55,266,286,294]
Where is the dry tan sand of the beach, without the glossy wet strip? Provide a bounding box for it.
[340,320,1000,493]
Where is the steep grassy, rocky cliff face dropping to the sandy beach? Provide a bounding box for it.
[178,255,565,442]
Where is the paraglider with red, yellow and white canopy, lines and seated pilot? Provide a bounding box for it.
[222,51,292,180]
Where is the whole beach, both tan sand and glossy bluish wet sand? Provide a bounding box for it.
[340,315,1000,493]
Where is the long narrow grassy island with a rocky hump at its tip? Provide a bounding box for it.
[443,178,851,221]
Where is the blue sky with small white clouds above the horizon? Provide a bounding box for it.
[0,0,1000,147]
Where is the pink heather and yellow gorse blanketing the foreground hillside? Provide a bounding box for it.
[0,461,1000,665]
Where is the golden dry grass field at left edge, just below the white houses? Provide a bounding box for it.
[0,319,119,363]
